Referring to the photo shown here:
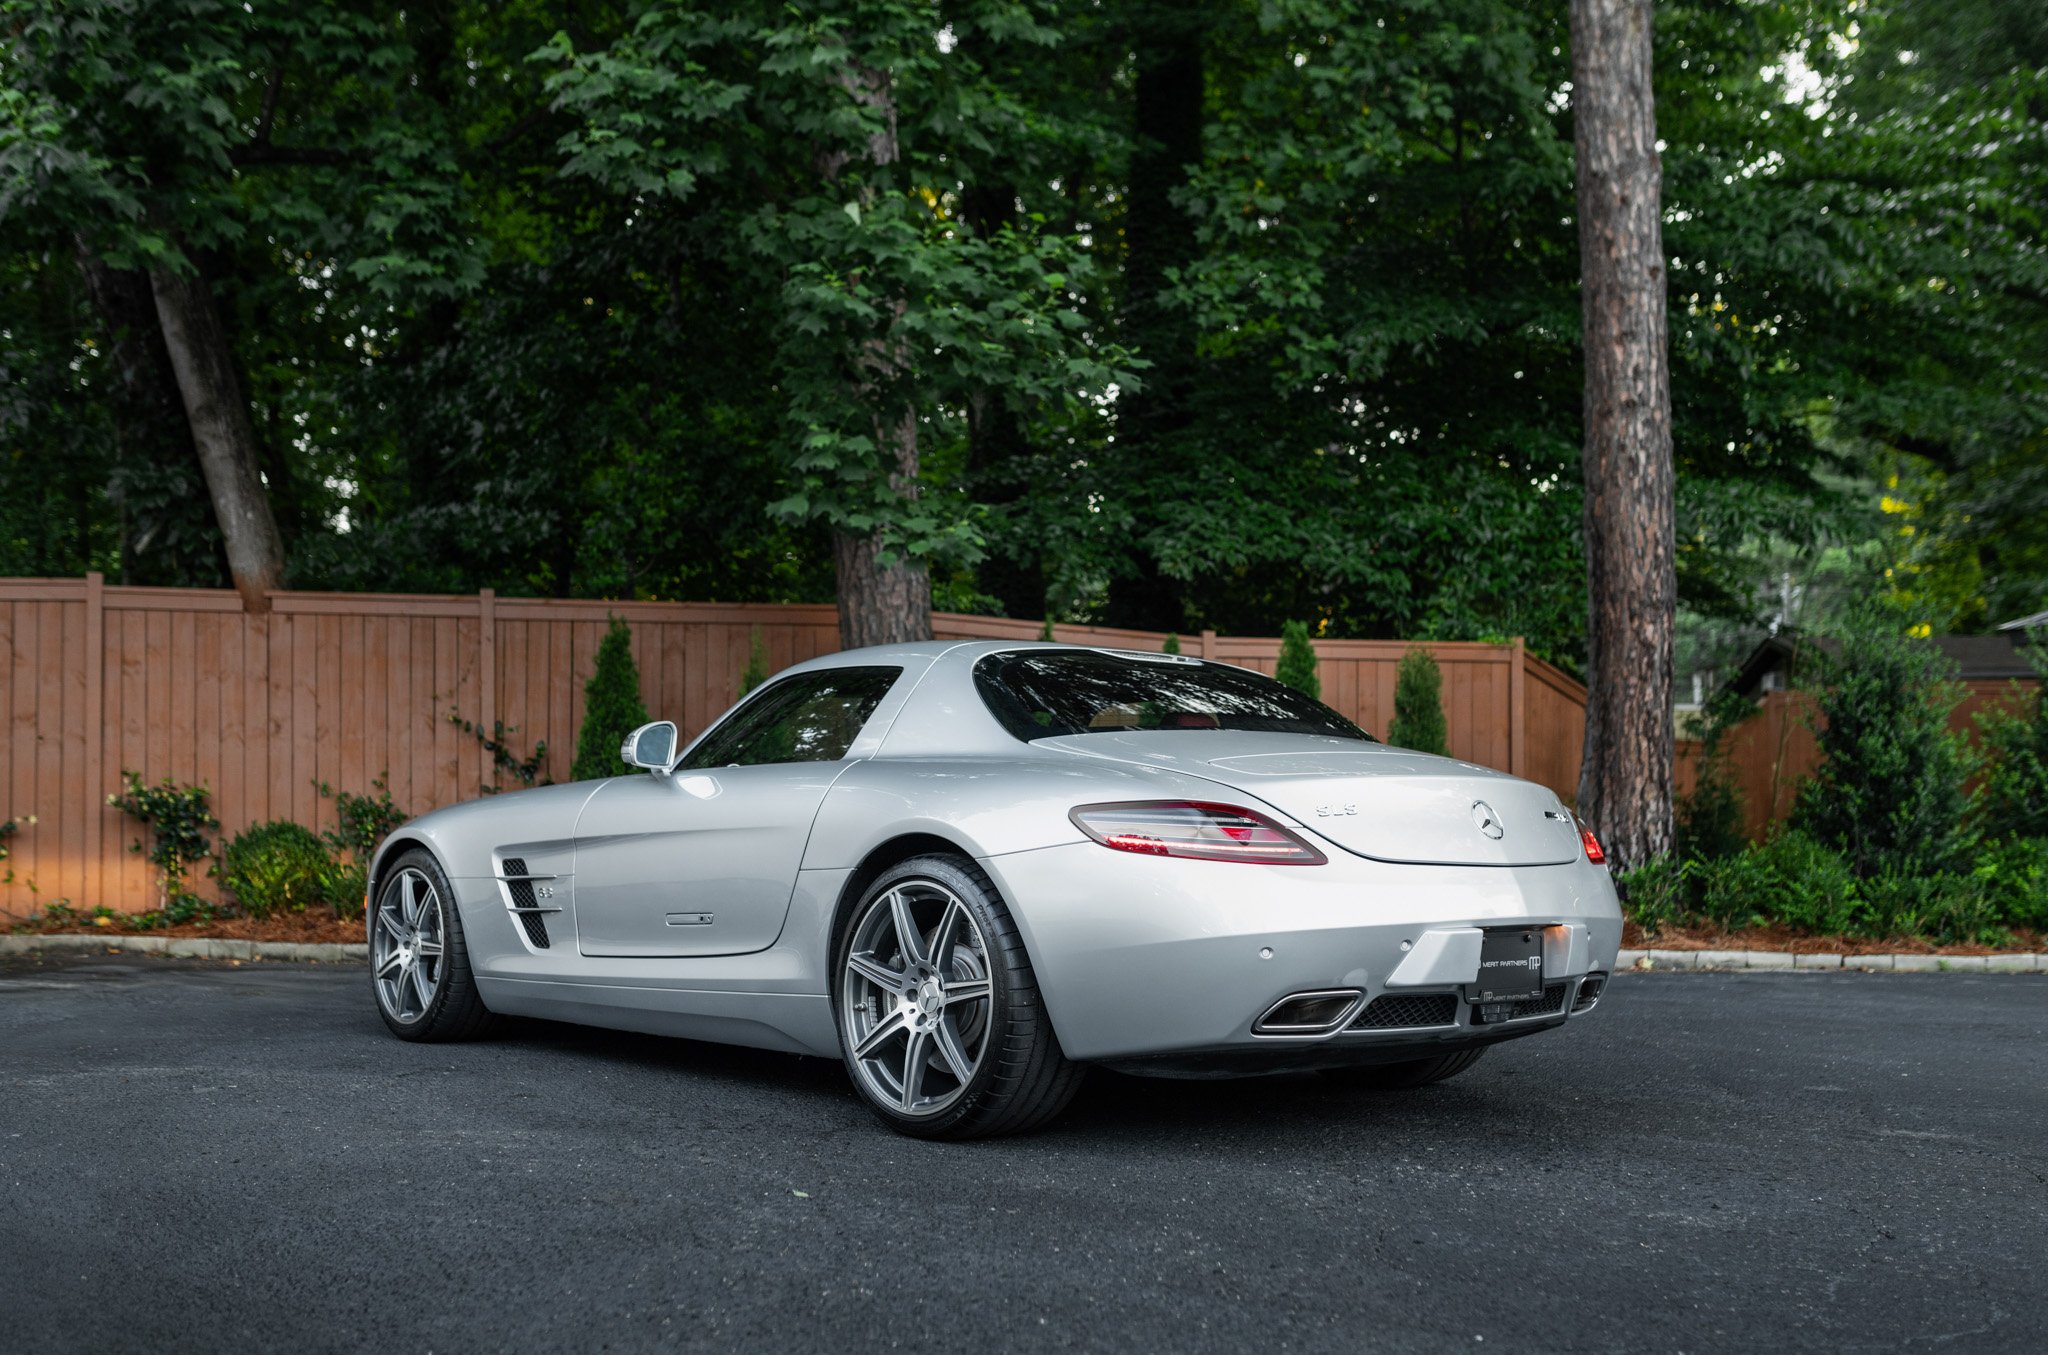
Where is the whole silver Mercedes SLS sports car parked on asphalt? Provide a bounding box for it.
[369,643,1622,1138]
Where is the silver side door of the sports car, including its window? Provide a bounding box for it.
[575,665,903,958]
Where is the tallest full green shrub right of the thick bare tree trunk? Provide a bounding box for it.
[1792,616,1970,878]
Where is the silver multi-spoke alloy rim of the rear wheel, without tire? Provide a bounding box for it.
[840,880,993,1116]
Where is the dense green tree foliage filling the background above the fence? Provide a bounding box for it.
[0,0,2048,667]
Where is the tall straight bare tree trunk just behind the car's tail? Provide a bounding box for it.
[1571,0,1677,868]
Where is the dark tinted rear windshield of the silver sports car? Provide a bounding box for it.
[975,649,1374,743]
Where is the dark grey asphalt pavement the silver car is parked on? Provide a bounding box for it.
[0,956,2048,1353]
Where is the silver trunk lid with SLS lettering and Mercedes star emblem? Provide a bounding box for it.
[1038,729,1581,866]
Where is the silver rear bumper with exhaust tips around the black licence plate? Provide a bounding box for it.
[981,843,1622,1075]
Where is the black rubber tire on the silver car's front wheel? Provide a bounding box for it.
[365,847,496,1044]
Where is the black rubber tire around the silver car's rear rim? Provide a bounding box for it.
[831,856,1085,1140]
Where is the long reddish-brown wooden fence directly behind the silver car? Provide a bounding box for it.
[0,575,1585,915]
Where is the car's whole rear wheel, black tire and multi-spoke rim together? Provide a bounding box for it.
[836,856,1081,1138]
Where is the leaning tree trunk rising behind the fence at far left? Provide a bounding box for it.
[150,268,285,612]
